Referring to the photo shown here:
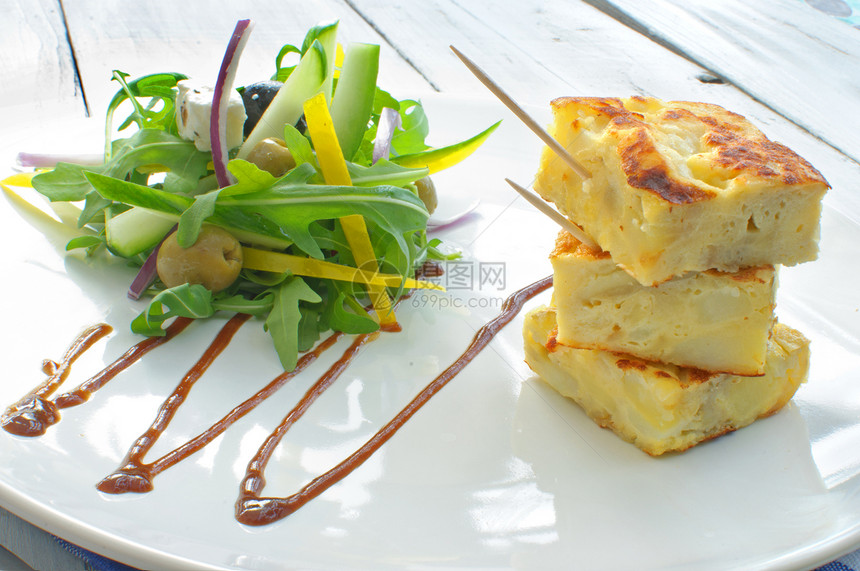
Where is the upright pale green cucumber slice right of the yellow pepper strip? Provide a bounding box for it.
[331,43,379,161]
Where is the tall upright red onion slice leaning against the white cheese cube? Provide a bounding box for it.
[209,20,254,188]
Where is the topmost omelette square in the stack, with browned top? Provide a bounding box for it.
[534,97,829,285]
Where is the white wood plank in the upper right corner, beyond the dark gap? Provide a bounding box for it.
[586,0,860,164]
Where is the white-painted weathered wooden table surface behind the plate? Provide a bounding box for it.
[0,0,860,569]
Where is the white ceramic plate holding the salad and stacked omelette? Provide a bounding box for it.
[0,99,860,570]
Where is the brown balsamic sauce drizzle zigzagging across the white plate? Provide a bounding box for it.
[5,276,552,525]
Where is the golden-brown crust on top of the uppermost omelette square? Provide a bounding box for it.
[552,97,829,204]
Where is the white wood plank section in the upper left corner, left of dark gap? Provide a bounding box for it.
[0,0,85,139]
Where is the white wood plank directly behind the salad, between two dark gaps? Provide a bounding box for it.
[58,0,432,116]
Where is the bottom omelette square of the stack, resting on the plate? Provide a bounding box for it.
[523,307,809,456]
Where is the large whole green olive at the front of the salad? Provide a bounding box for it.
[156,225,242,292]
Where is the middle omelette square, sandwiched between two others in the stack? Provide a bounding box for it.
[550,231,777,375]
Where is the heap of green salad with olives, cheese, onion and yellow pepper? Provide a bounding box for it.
[11,20,499,371]
